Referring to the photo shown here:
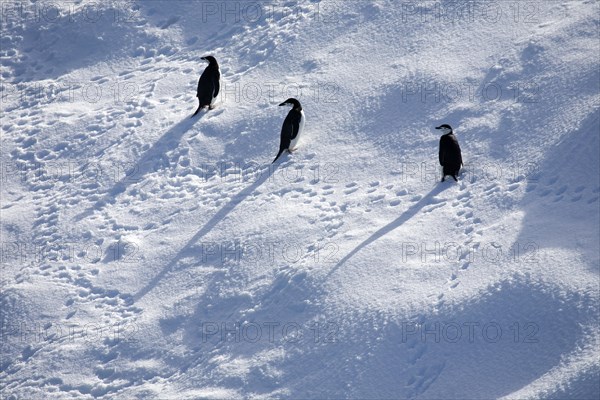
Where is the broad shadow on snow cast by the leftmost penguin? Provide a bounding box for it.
[75,115,202,221]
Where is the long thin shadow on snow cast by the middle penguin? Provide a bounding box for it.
[133,165,275,301]
